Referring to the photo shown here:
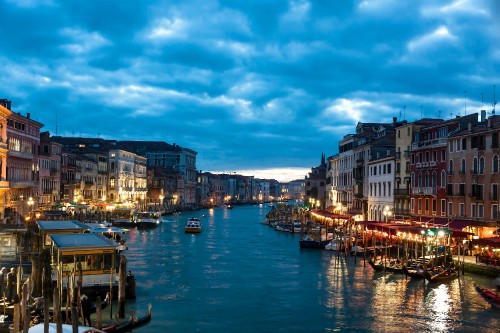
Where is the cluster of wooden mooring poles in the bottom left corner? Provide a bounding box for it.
[4,256,127,333]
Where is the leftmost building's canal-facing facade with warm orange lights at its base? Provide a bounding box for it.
[7,105,43,219]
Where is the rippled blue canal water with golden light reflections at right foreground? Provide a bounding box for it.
[115,205,500,333]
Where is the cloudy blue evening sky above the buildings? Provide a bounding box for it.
[0,0,500,179]
